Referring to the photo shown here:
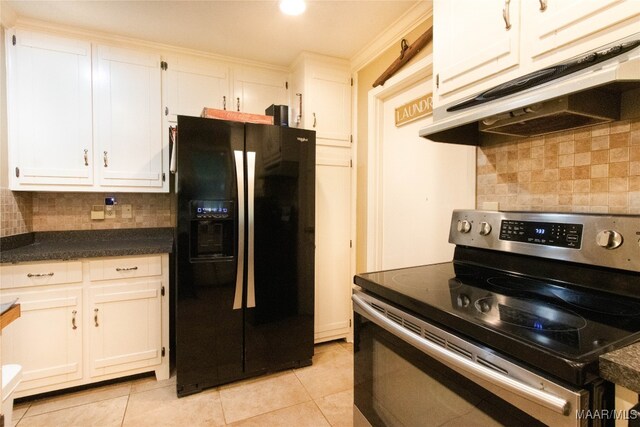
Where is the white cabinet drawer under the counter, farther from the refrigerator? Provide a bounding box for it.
[0,261,82,289]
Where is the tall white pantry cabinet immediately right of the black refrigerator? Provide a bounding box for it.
[289,53,353,343]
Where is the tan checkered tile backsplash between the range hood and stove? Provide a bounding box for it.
[476,119,640,214]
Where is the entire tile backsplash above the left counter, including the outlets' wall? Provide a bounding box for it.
[0,188,175,237]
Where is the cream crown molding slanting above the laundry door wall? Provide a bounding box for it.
[351,0,433,72]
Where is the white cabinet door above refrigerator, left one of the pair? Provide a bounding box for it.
[166,57,232,122]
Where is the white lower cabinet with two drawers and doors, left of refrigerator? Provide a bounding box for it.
[0,254,169,397]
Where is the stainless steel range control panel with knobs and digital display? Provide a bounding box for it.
[449,210,640,271]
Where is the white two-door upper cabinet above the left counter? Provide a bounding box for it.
[6,29,169,196]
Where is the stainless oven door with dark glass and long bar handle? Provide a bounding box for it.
[353,291,597,426]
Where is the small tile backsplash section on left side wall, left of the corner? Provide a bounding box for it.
[0,188,33,237]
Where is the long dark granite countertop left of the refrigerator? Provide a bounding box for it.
[0,227,174,262]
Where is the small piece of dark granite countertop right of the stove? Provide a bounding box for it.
[599,342,640,393]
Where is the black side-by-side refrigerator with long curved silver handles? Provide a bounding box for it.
[174,116,315,397]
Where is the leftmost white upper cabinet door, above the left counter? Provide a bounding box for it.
[7,30,93,190]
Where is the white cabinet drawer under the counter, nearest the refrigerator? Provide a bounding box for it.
[89,255,162,281]
